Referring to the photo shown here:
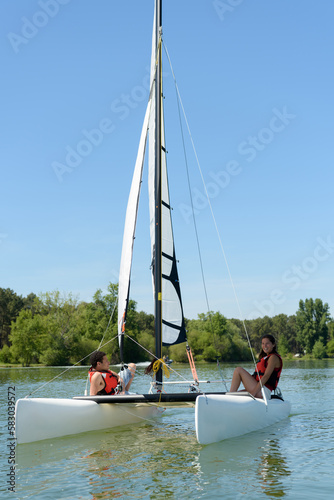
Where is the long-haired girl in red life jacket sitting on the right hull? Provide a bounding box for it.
[230,335,283,399]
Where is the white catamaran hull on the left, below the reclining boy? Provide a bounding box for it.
[15,398,161,444]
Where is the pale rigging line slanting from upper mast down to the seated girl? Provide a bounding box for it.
[164,44,262,372]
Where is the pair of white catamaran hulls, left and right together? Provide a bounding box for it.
[16,394,291,444]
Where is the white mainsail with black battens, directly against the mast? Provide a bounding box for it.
[148,6,186,345]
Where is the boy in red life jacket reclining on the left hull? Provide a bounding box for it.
[88,351,136,396]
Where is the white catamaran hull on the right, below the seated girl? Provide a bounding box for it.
[195,394,291,444]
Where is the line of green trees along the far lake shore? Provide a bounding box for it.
[0,283,334,366]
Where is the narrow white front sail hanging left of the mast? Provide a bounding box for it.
[118,100,151,342]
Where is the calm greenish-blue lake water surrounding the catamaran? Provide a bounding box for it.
[0,360,334,500]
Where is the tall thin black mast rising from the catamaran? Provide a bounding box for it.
[154,0,162,384]
